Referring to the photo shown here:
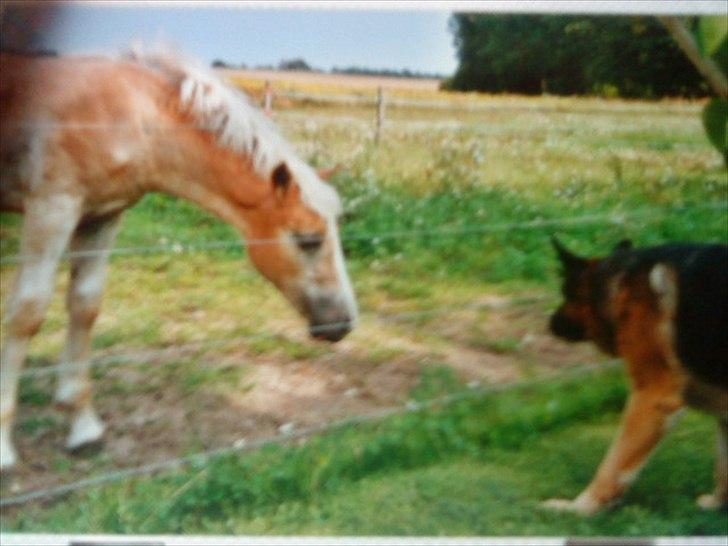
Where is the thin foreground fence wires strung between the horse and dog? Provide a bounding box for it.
[0,199,726,507]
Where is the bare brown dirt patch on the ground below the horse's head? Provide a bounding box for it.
[2,296,604,502]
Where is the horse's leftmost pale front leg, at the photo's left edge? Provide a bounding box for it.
[0,194,81,471]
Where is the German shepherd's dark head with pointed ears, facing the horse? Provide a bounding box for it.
[549,237,632,352]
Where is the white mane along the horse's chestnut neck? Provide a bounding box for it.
[126,46,340,216]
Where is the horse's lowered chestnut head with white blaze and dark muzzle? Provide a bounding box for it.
[247,159,357,341]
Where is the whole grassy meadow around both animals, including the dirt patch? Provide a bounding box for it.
[0,82,728,535]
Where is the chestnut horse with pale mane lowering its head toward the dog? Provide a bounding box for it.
[0,49,357,470]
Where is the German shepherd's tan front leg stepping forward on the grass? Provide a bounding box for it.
[543,382,682,515]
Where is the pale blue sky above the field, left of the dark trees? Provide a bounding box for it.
[25,4,457,75]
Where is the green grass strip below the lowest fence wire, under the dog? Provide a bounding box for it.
[3,371,726,535]
